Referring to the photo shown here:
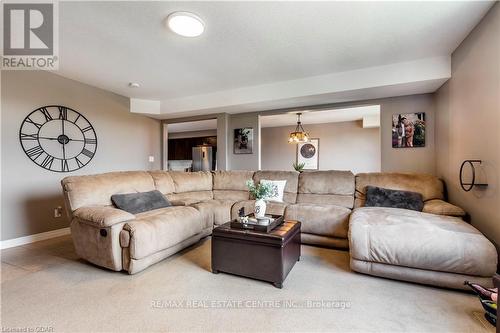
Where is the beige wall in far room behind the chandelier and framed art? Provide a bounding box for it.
[261,121,380,173]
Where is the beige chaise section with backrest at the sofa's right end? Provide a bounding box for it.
[349,173,497,289]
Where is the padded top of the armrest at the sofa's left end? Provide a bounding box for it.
[73,206,135,228]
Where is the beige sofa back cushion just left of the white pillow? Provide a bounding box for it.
[213,170,254,202]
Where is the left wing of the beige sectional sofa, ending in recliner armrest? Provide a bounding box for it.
[62,171,207,274]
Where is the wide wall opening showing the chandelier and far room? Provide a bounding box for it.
[260,105,381,173]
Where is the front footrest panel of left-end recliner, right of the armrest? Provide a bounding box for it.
[123,206,202,259]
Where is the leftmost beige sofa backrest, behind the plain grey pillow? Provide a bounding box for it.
[61,171,155,211]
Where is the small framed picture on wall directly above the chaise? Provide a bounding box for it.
[392,112,425,148]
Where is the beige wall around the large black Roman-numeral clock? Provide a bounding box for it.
[1,71,160,240]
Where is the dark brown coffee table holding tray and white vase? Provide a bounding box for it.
[212,221,300,288]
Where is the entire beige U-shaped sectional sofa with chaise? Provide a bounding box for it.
[62,170,497,288]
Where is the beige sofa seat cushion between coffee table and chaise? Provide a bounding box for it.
[285,203,351,238]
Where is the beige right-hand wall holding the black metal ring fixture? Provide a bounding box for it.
[436,3,500,248]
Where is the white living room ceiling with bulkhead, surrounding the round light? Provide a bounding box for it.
[58,1,493,117]
